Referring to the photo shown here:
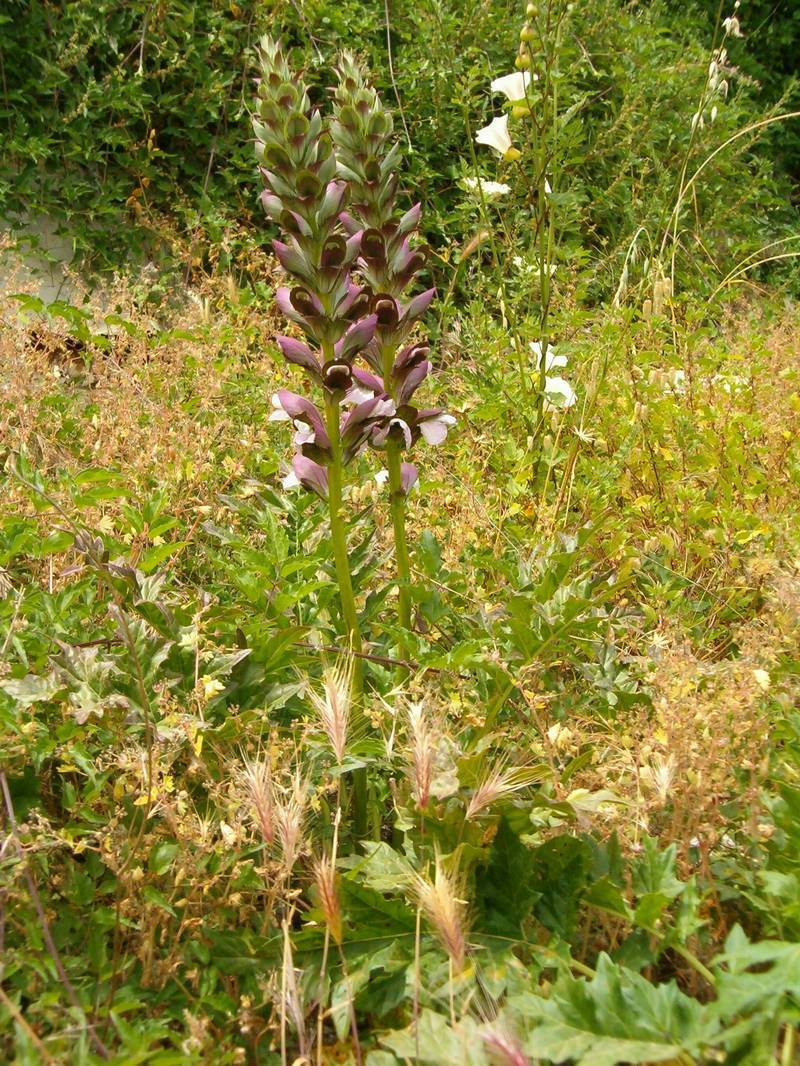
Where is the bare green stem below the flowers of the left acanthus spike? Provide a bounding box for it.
[325,393,367,840]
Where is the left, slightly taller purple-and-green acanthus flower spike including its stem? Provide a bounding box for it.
[253,36,371,838]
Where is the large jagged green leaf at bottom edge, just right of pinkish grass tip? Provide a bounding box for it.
[510,954,720,1066]
